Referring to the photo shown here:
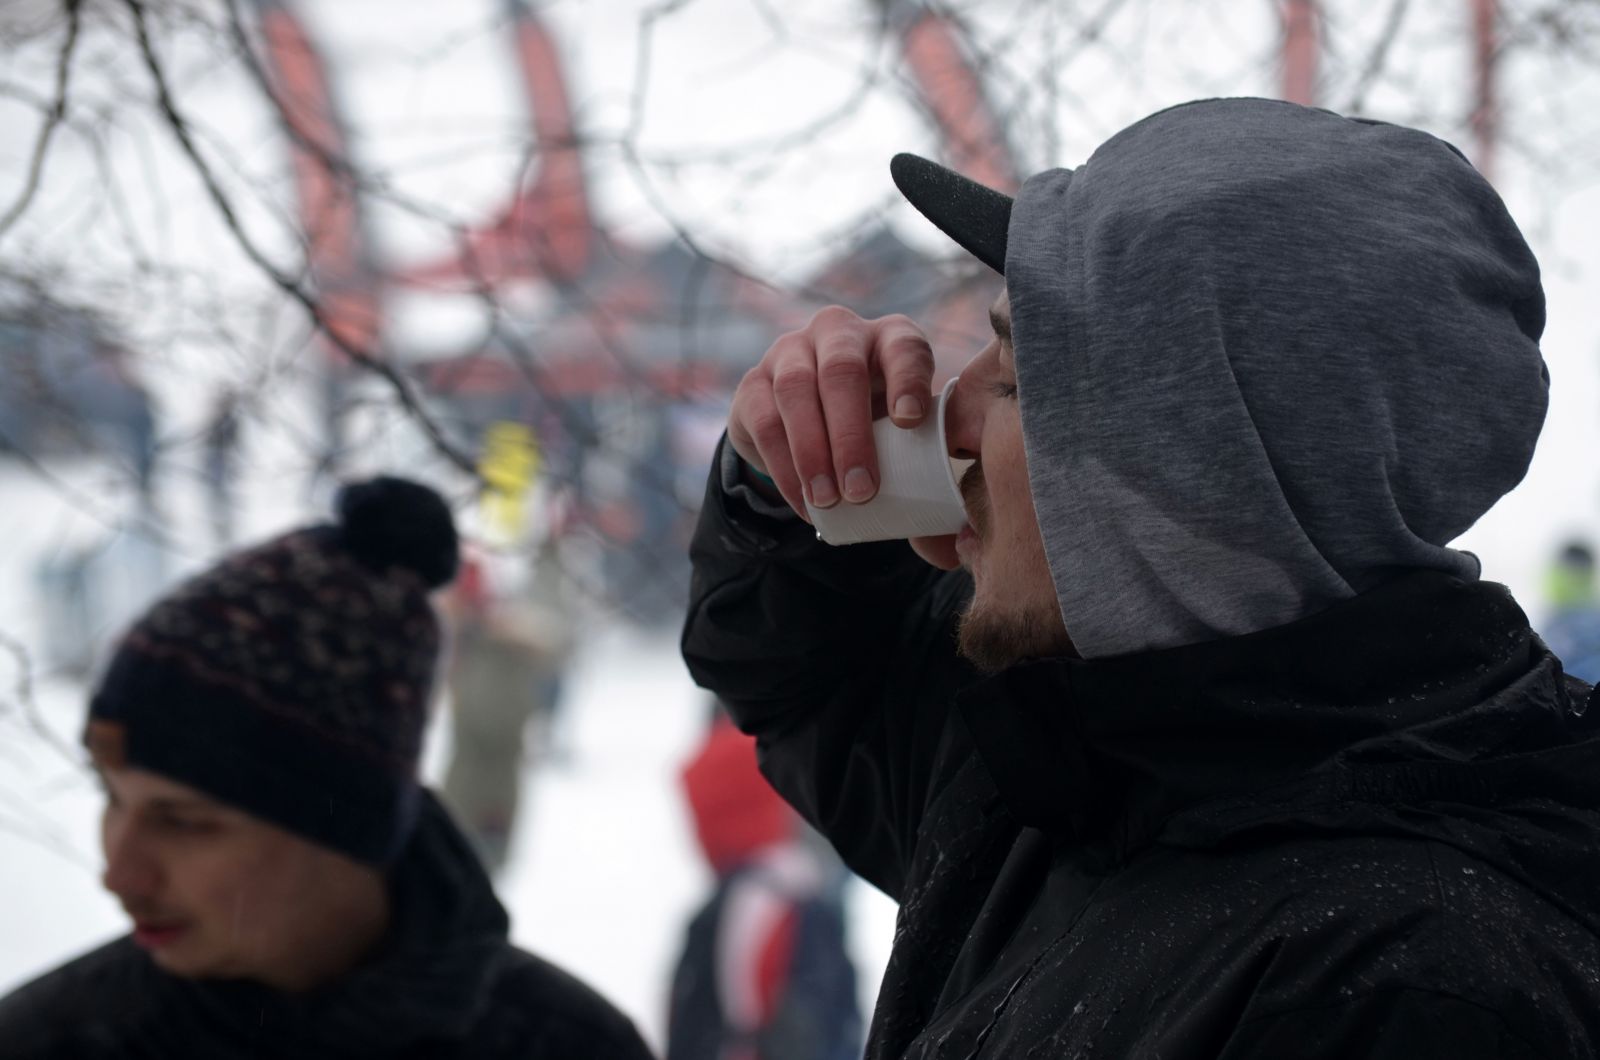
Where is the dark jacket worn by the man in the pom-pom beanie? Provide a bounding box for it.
[0,796,650,1060]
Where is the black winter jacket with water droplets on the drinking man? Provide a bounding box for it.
[683,476,1600,1060]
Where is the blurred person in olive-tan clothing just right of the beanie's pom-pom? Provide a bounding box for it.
[440,538,574,873]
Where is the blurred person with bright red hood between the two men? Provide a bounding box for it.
[667,705,861,1060]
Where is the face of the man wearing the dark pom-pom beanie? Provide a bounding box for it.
[99,767,387,991]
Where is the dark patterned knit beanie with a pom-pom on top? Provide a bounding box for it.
[85,477,459,866]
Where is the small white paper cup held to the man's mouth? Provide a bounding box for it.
[805,379,973,544]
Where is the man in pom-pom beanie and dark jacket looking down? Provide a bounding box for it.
[0,479,650,1060]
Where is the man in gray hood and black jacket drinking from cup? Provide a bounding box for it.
[683,99,1600,1060]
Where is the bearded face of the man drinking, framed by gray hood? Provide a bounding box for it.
[925,295,1072,673]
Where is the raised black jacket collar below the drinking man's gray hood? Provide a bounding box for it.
[957,572,1581,853]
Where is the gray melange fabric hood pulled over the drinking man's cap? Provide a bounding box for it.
[1005,99,1549,658]
